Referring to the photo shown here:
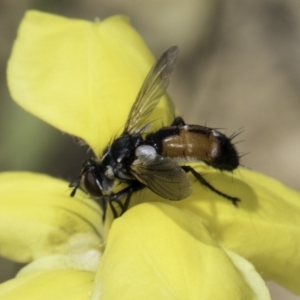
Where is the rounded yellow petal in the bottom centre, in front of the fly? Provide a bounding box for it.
[92,203,269,300]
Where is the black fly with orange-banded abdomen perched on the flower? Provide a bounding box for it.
[70,46,240,220]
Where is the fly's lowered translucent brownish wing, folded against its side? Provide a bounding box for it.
[131,146,191,200]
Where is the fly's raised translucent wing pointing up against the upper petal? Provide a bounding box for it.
[124,46,178,134]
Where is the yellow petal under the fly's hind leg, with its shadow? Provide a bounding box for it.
[126,165,300,294]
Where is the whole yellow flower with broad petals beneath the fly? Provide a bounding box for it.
[0,11,300,300]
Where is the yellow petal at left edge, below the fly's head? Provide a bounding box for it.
[0,172,103,262]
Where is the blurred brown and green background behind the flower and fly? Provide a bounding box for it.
[0,0,300,300]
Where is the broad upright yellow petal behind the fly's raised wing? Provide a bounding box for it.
[7,11,174,155]
